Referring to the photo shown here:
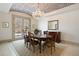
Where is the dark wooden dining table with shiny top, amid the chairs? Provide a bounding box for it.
[33,35,52,53]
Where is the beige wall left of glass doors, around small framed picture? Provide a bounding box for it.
[0,12,12,41]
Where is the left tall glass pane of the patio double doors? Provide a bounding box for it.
[15,17,23,39]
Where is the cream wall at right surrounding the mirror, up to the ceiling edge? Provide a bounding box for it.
[38,4,79,43]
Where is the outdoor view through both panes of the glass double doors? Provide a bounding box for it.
[14,16,31,40]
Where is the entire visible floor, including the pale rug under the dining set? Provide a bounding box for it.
[0,40,79,56]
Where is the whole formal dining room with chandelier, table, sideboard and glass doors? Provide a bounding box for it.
[0,3,79,56]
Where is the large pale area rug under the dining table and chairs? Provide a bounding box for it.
[12,40,66,56]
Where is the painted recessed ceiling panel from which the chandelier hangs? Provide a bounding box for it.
[10,3,74,15]
